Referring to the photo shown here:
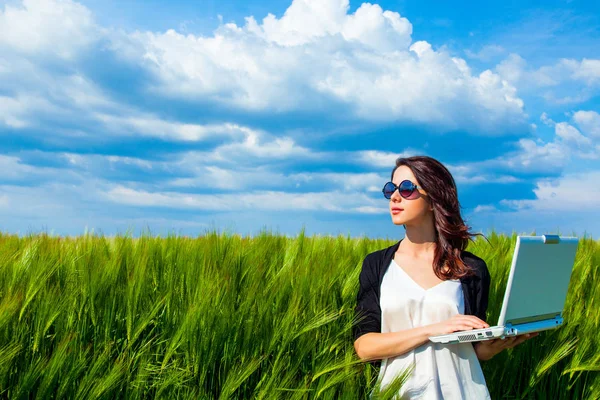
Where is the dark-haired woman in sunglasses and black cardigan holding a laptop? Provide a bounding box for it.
[354,156,535,399]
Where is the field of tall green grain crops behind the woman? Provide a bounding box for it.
[0,232,600,399]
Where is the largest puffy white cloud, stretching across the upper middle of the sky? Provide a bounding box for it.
[113,0,526,134]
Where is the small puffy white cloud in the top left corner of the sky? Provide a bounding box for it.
[0,0,98,59]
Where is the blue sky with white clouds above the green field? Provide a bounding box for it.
[0,0,600,238]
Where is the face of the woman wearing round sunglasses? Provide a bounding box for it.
[390,165,432,225]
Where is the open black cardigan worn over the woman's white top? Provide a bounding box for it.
[353,240,490,340]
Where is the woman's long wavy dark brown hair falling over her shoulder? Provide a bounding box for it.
[392,156,483,280]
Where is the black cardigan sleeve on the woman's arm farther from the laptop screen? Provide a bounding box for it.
[353,256,381,341]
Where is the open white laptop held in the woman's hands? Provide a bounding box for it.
[429,235,579,344]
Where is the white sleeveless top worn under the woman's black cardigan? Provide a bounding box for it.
[379,260,490,400]
